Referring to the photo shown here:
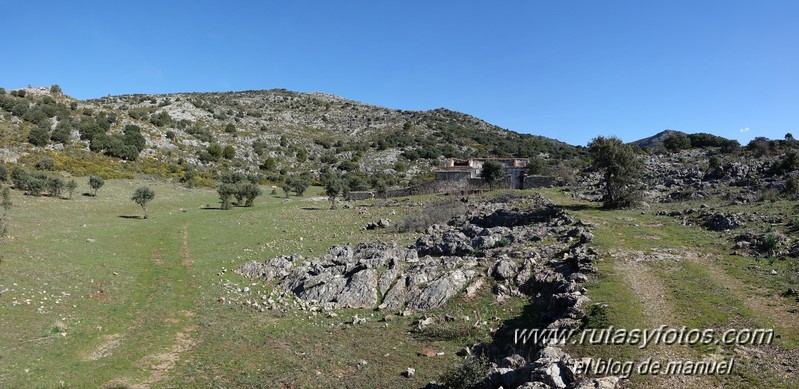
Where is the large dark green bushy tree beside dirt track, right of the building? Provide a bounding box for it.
[588,136,644,208]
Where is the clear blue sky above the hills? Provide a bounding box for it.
[0,0,799,145]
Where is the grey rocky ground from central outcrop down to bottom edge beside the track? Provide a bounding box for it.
[236,196,619,388]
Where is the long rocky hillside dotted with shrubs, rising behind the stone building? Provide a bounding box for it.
[0,88,578,189]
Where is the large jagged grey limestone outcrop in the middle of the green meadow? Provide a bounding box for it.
[237,192,593,316]
